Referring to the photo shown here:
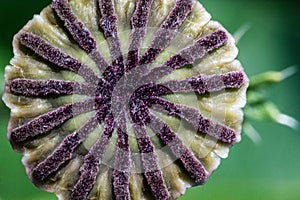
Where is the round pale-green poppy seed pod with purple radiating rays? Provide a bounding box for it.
[4,0,248,200]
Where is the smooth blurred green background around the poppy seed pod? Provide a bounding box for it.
[0,0,300,200]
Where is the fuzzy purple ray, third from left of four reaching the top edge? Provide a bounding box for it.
[126,0,153,71]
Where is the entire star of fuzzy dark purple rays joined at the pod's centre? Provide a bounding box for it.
[7,0,247,200]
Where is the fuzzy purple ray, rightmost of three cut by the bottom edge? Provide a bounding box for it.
[135,126,170,200]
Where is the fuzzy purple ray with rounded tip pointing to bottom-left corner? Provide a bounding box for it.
[32,112,101,182]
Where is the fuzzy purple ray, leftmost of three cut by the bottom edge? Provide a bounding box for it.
[70,116,115,200]
